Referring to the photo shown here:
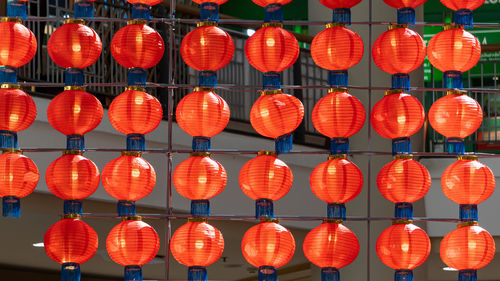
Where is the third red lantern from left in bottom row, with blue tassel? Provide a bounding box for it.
[170,219,224,281]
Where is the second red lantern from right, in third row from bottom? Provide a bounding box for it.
[371,90,425,139]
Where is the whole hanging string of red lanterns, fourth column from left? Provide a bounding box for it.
[170,0,229,281]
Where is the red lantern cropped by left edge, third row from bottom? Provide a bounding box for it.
[0,87,37,132]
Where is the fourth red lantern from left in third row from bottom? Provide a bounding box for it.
[175,88,230,138]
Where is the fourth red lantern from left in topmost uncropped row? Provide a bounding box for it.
[181,26,234,71]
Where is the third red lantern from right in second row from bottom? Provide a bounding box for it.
[309,156,363,203]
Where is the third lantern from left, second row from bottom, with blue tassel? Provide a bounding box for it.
[101,151,156,216]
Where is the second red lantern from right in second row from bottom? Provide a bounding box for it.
[377,156,432,203]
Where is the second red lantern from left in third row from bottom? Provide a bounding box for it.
[47,89,103,136]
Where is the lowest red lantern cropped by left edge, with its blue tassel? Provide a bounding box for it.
[0,149,40,218]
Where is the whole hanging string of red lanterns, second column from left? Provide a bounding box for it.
[44,1,103,281]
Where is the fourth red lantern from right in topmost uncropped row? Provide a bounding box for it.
[245,26,299,72]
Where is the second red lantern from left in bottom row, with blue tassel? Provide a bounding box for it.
[106,217,160,281]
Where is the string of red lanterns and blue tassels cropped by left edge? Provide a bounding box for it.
[0,1,40,218]
